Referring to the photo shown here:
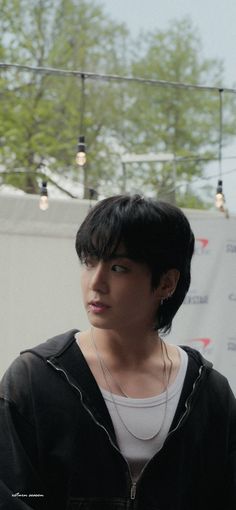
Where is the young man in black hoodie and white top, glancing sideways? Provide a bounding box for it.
[0,195,236,510]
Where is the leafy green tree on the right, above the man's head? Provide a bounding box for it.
[123,19,235,203]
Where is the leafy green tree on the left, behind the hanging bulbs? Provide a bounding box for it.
[0,0,128,194]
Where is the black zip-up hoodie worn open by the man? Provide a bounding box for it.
[0,330,236,510]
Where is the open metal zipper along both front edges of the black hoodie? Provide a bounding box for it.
[47,359,204,503]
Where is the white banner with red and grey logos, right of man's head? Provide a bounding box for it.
[168,211,236,393]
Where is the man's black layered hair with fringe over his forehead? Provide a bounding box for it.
[76,195,194,333]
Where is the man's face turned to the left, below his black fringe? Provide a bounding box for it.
[81,249,161,329]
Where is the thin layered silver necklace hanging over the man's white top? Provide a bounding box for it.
[90,328,173,441]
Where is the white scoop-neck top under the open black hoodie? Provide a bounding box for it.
[100,347,188,480]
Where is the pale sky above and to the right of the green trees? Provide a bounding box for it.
[98,0,236,214]
